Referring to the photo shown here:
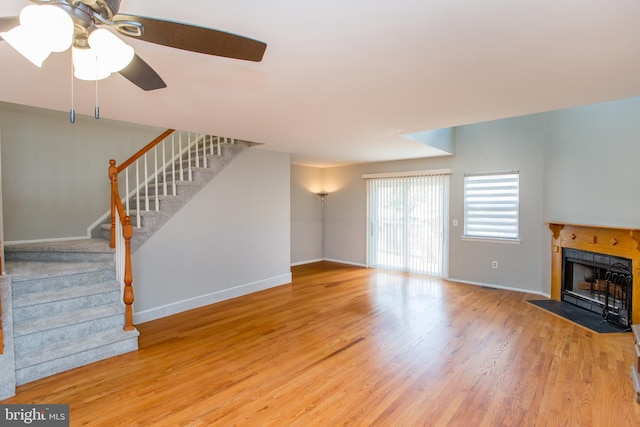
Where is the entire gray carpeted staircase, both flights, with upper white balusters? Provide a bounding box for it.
[5,132,251,385]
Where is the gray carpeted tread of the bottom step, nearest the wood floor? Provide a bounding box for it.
[16,329,140,369]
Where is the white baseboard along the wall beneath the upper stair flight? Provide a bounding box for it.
[138,273,291,324]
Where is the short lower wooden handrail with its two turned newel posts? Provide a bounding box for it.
[109,159,135,331]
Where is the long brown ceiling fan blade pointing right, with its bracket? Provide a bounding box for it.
[113,14,267,62]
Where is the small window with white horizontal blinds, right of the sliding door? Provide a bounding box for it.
[464,171,520,240]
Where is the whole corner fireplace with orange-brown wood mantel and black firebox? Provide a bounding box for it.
[548,222,640,327]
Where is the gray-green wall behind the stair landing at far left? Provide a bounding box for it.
[0,103,164,241]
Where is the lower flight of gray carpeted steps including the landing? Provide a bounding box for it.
[5,239,138,385]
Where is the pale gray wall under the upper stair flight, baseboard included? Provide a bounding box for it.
[133,148,291,323]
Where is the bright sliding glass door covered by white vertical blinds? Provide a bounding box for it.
[367,174,449,277]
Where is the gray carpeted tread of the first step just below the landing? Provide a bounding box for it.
[5,261,115,283]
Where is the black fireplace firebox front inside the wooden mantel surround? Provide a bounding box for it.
[562,248,633,326]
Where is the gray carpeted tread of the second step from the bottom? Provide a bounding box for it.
[13,303,124,338]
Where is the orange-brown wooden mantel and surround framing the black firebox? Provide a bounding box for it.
[547,222,640,324]
